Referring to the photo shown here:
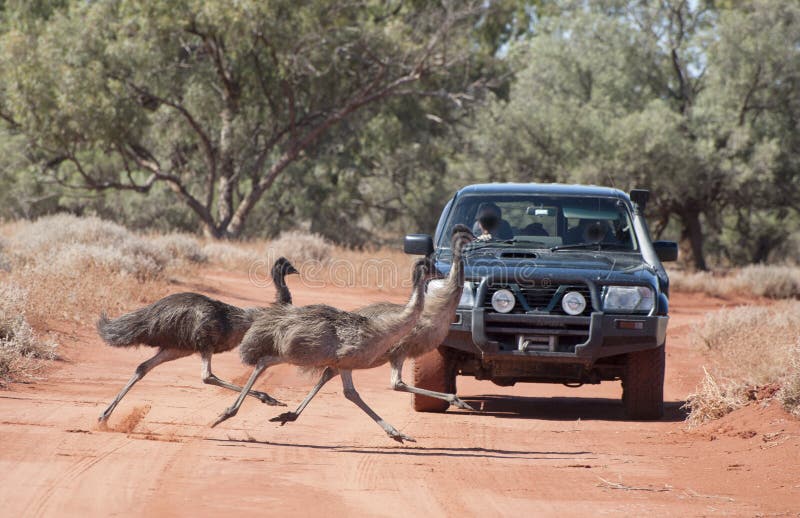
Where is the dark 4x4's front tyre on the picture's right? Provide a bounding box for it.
[622,345,666,420]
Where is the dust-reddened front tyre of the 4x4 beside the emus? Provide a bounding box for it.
[411,347,456,412]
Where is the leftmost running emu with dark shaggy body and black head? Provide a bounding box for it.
[97,257,298,421]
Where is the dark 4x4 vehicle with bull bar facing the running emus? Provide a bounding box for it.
[406,184,678,419]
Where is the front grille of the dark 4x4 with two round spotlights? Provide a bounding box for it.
[483,283,592,316]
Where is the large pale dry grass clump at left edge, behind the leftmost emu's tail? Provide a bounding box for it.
[3,214,187,326]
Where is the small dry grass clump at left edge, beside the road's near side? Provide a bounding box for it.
[0,283,56,385]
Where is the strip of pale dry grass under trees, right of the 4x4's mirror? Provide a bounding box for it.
[669,265,800,299]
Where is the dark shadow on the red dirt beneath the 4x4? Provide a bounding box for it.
[462,394,688,423]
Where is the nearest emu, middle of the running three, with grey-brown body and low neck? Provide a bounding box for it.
[212,258,433,442]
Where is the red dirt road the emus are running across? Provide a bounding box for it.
[0,272,800,517]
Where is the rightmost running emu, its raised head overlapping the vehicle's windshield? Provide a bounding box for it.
[270,224,475,425]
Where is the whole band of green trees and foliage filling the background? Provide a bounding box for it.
[0,0,800,269]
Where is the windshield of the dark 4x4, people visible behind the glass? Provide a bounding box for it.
[438,194,638,251]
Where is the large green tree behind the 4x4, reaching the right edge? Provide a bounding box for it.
[460,0,800,269]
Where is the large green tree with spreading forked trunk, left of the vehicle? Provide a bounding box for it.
[0,0,488,237]
